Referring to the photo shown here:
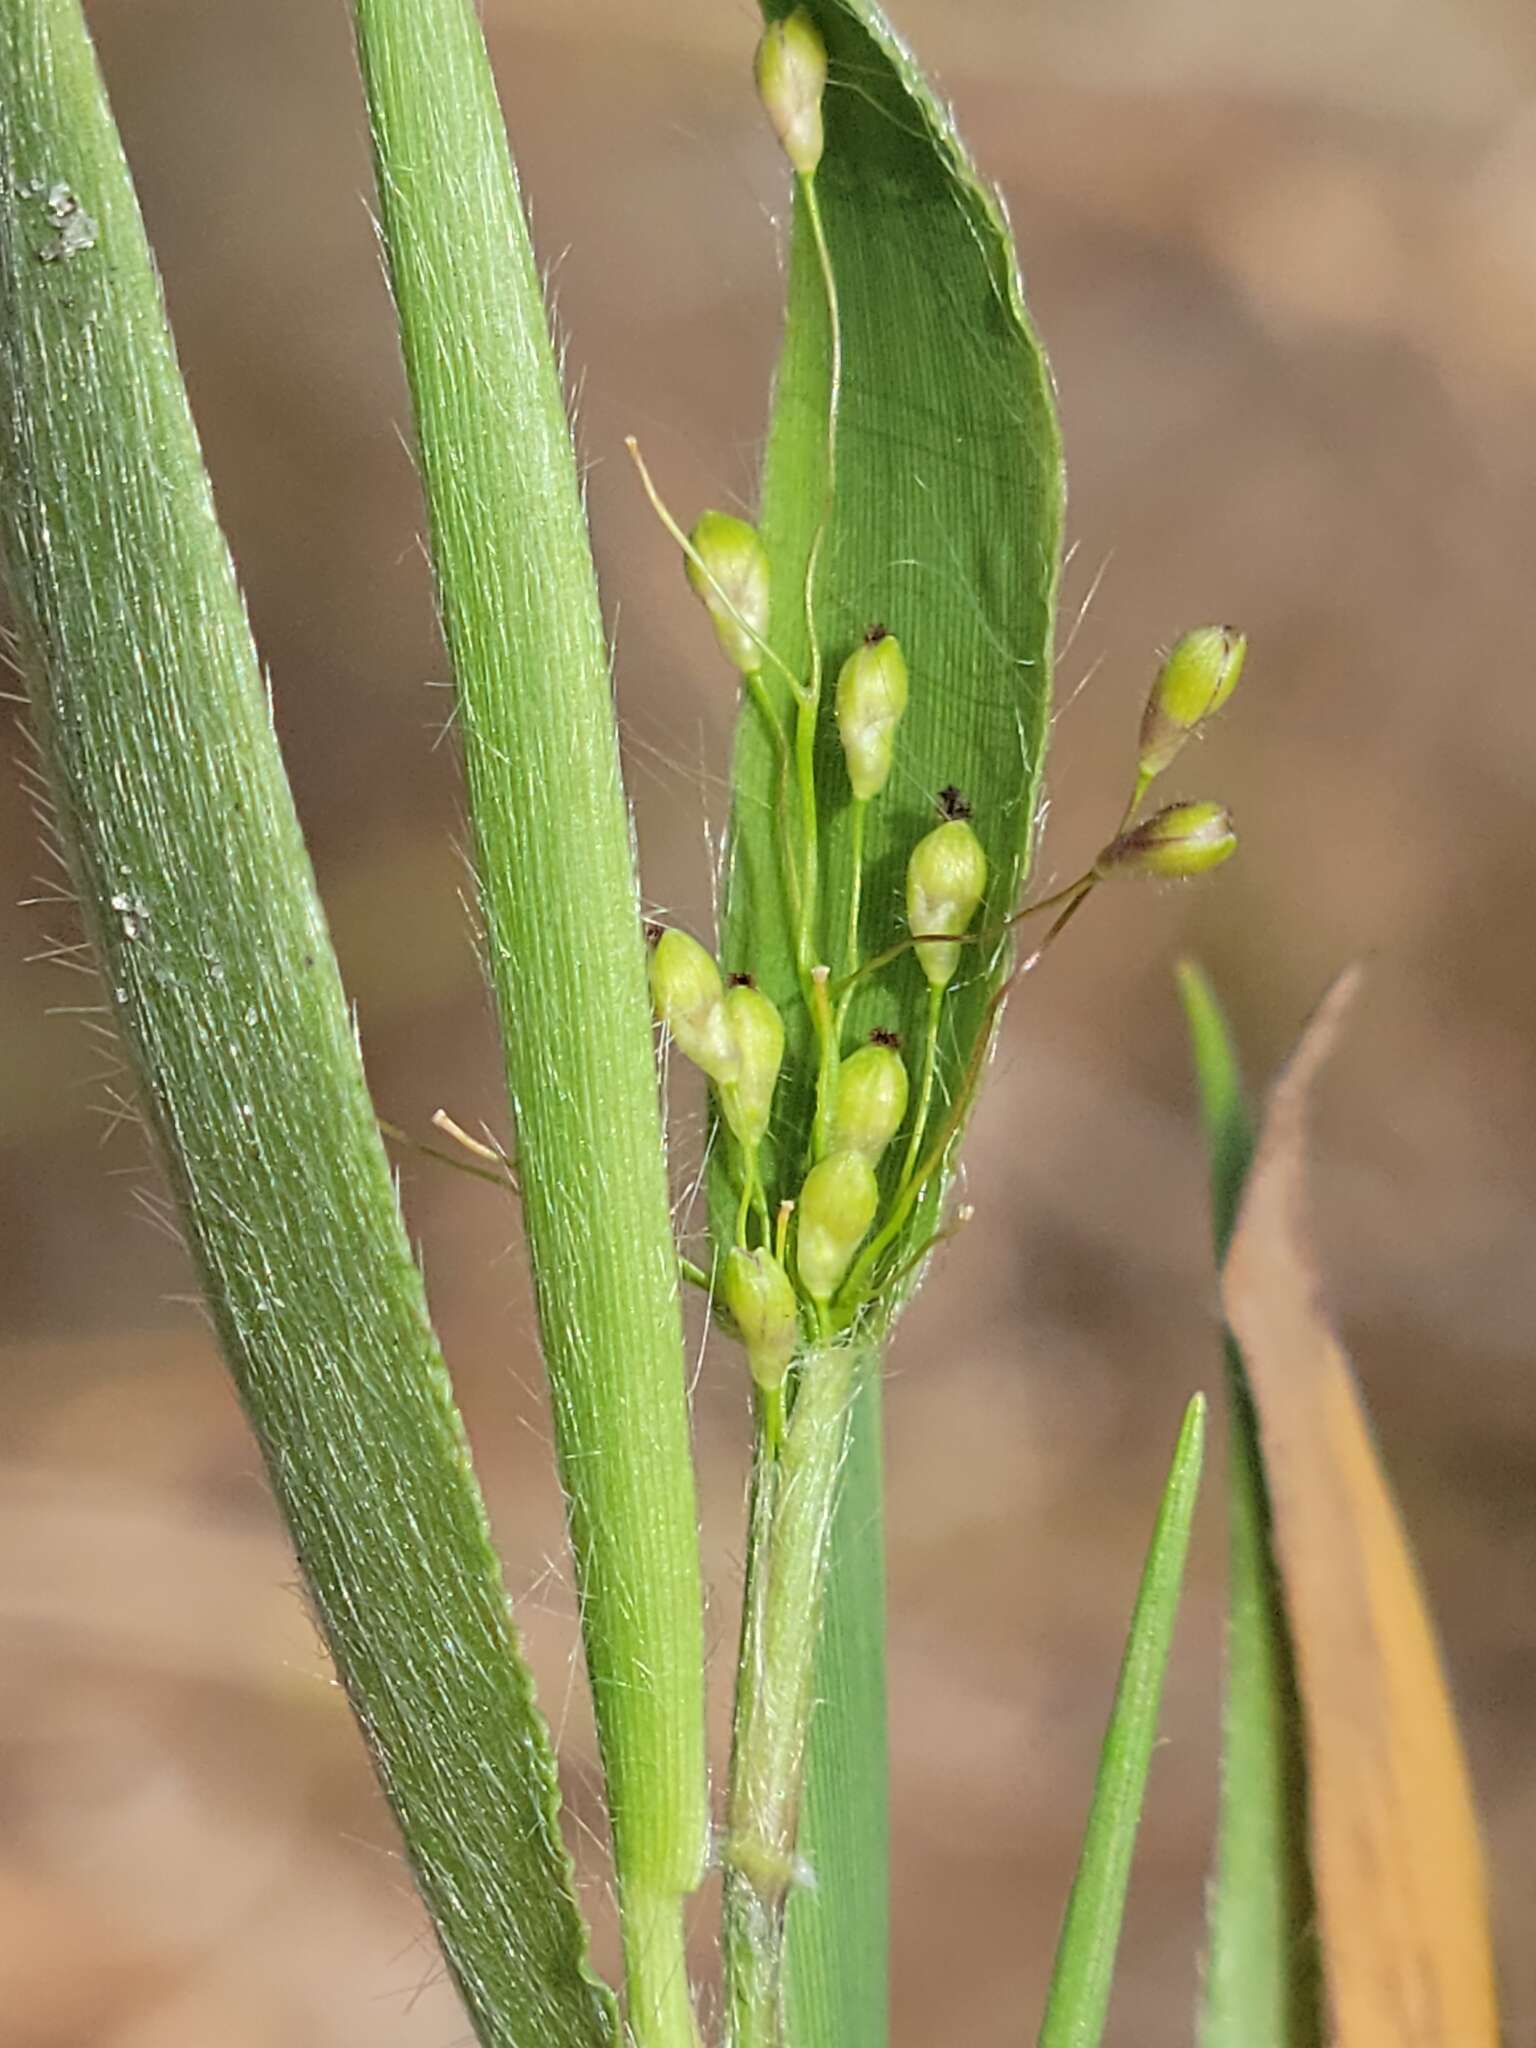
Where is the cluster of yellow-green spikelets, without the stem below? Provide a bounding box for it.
[647,12,1245,1393]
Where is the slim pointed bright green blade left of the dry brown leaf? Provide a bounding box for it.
[1040,1395,1206,2048]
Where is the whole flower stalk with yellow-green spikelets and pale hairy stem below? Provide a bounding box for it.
[631,10,1243,2048]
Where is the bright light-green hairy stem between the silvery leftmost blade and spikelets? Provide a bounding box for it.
[354,0,709,2042]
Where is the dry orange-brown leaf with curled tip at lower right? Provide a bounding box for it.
[1223,973,1499,2048]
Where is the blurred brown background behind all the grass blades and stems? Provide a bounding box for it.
[0,0,1536,2048]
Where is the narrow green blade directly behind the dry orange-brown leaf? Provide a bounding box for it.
[1180,963,1323,2048]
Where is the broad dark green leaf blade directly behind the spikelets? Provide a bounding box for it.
[723,0,1065,1243]
